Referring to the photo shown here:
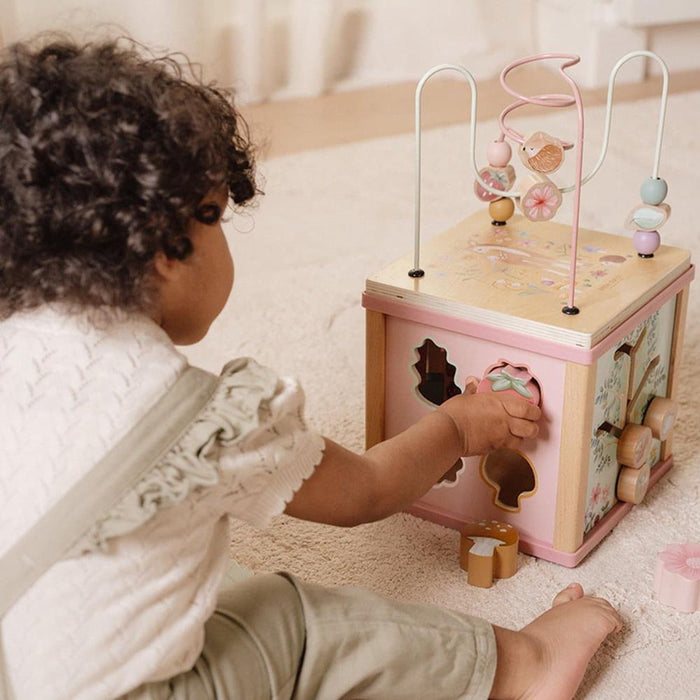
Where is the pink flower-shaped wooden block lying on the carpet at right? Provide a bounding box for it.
[654,542,700,612]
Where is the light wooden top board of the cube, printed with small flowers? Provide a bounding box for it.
[366,210,690,348]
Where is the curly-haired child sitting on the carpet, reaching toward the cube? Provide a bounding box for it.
[0,39,621,700]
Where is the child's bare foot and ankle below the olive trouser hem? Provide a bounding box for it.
[491,583,622,700]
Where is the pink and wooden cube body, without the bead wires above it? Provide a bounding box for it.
[363,211,694,566]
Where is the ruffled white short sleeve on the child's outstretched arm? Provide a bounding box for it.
[75,358,325,553]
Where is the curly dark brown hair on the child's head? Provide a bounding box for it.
[0,37,258,318]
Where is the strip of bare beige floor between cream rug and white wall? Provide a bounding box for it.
[243,67,700,158]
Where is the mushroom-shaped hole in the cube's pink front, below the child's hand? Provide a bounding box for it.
[480,447,537,512]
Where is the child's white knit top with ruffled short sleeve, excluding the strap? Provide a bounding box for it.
[0,307,324,700]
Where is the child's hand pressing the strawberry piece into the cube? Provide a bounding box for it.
[437,382,542,457]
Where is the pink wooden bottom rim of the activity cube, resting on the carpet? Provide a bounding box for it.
[407,456,673,568]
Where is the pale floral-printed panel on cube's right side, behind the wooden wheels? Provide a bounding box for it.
[584,298,676,532]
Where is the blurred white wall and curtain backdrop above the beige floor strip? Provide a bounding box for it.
[0,0,700,101]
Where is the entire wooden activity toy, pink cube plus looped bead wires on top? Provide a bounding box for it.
[363,51,694,566]
